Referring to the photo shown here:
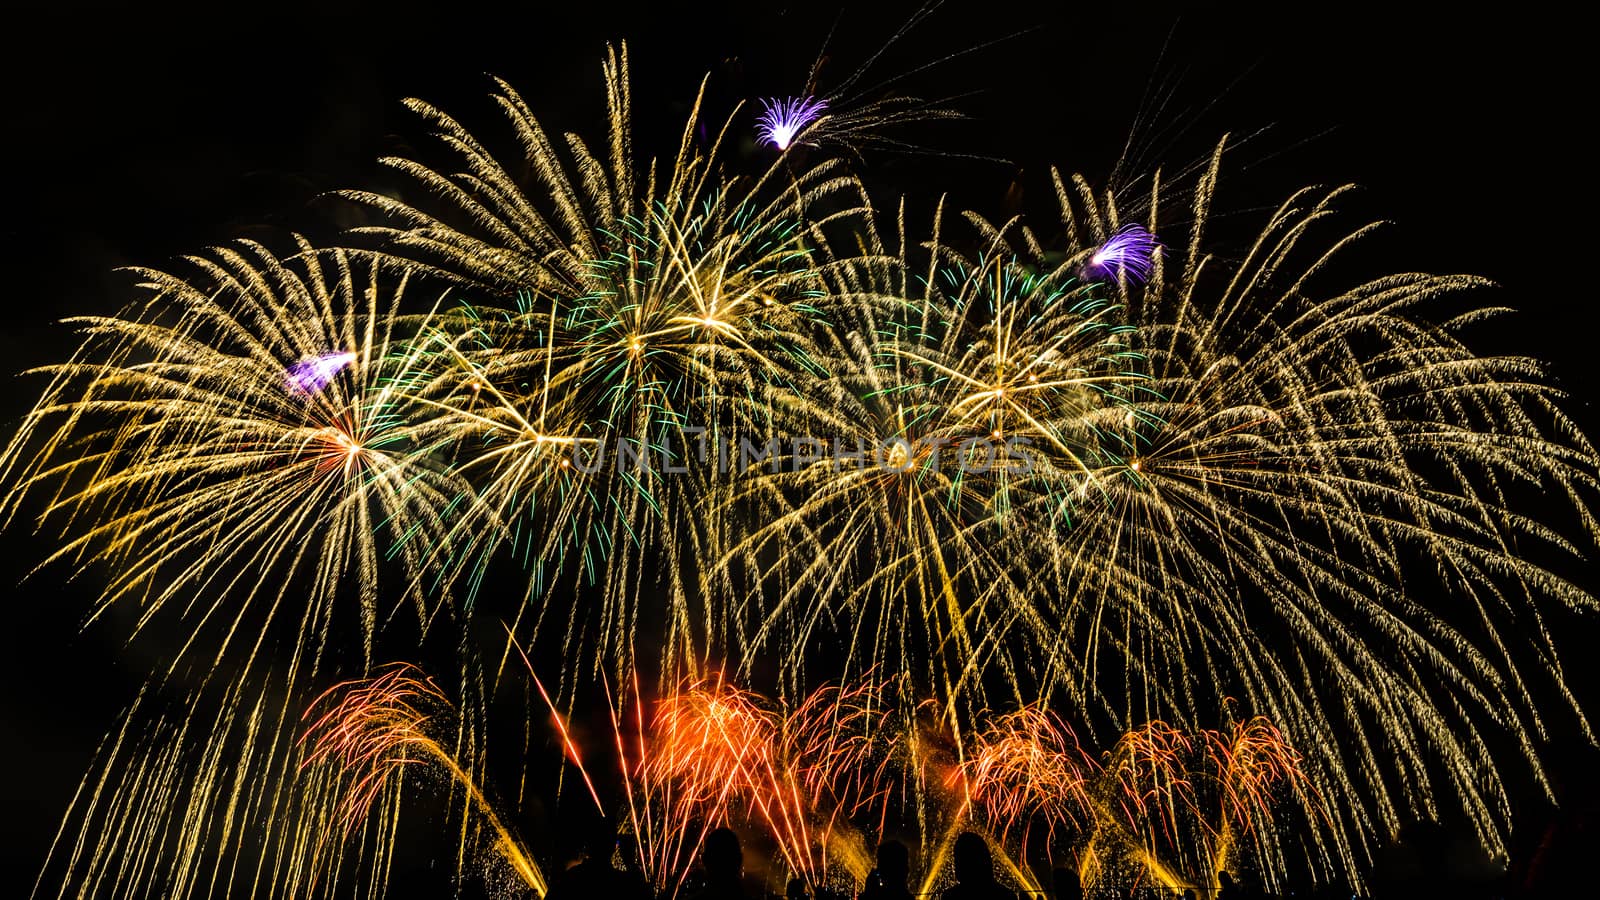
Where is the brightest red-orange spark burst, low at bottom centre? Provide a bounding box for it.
[534,676,901,892]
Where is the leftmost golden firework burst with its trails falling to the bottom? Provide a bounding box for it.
[3,243,480,895]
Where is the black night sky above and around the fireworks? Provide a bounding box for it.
[0,0,1600,895]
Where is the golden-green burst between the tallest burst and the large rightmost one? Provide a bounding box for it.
[723,199,1138,709]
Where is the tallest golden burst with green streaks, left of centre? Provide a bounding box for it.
[350,50,864,690]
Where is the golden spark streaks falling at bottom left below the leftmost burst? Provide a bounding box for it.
[28,666,444,900]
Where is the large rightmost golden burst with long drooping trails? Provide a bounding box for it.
[985,143,1597,878]
